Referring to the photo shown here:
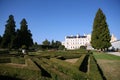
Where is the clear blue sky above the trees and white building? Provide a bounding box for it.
[0,0,120,44]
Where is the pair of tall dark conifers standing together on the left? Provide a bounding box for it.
[0,15,33,49]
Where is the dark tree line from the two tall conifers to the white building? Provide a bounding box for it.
[0,15,64,50]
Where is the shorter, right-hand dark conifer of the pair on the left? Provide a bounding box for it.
[17,19,33,48]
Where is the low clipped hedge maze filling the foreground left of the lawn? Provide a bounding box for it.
[0,51,105,80]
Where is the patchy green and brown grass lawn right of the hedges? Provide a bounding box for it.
[93,52,120,80]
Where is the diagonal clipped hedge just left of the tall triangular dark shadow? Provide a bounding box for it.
[50,58,87,80]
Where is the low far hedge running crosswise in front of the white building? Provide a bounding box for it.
[36,50,87,59]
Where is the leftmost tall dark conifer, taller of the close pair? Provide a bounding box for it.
[1,15,16,48]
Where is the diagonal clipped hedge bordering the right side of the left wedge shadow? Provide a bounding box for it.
[34,58,72,80]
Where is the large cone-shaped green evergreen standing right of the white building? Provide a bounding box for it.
[91,9,111,50]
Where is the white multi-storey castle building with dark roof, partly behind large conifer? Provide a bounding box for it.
[62,34,117,50]
